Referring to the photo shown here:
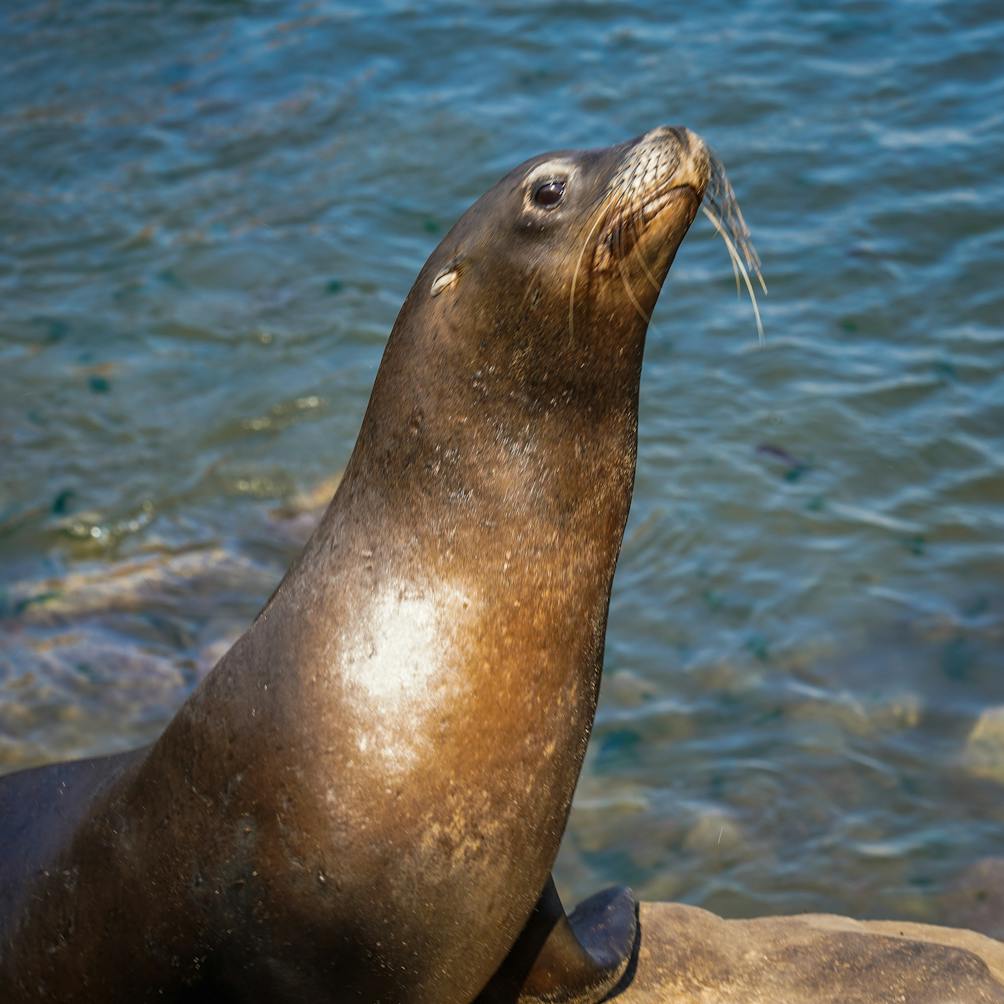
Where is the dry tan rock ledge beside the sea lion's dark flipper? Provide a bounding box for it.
[607,903,1004,1004]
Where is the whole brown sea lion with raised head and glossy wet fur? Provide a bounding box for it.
[0,128,712,1004]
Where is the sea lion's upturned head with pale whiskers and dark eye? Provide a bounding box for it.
[383,127,713,408]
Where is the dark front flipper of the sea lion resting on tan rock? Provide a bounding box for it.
[477,877,638,1004]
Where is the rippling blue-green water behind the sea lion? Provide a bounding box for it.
[0,0,1004,926]
